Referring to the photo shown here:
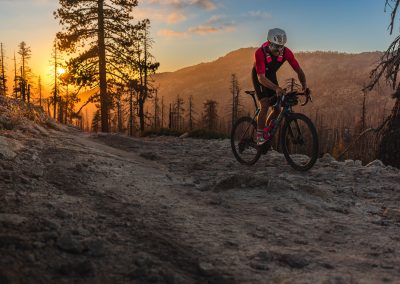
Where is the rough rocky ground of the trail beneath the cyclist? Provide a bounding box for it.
[0,117,400,283]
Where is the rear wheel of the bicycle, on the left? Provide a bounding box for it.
[231,117,261,165]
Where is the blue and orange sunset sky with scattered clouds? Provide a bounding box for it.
[0,0,399,87]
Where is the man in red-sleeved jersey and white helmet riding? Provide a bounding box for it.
[252,28,309,145]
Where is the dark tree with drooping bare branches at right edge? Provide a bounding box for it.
[367,0,400,167]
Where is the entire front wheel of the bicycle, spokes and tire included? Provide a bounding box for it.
[281,113,318,171]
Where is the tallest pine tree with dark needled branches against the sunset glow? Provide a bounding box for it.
[54,0,137,132]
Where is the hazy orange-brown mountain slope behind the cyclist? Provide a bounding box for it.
[155,48,393,129]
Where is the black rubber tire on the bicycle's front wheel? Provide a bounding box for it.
[280,113,319,171]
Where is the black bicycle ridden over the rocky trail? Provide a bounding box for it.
[231,82,318,171]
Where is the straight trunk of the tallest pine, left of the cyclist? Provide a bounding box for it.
[97,0,109,132]
